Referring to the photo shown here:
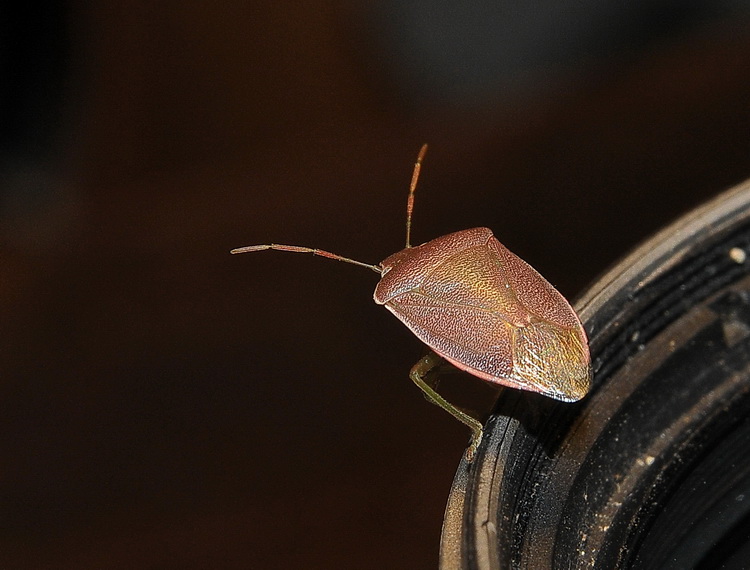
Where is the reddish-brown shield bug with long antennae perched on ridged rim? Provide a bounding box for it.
[231,145,591,461]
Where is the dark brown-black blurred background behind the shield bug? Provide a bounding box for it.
[0,0,750,569]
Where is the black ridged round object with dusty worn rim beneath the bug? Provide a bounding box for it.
[441,181,750,570]
